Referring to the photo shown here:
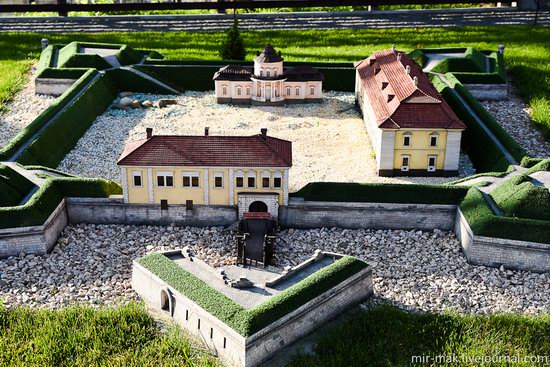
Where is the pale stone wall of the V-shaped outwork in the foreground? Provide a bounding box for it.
[132,262,373,367]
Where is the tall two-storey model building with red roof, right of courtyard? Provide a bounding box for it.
[355,48,466,176]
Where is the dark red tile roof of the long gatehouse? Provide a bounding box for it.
[118,134,292,167]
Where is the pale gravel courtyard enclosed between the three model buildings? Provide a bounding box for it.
[58,92,473,191]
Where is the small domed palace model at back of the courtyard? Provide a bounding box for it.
[213,45,324,105]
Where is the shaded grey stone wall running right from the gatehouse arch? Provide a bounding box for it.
[279,200,456,231]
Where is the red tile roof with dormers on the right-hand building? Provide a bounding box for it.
[355,50,466,129]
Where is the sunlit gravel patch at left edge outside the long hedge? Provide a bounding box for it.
[0,71,55,147]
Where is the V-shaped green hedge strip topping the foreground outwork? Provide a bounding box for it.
[138,253,367,336]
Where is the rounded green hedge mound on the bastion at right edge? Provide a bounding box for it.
[490,174,550,221]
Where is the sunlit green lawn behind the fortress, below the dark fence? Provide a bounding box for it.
[0,26,550,137]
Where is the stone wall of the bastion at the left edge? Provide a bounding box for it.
[0,200,67,258]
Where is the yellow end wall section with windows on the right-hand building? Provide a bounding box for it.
[394,129,447,170]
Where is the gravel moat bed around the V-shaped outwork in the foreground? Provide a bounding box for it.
[0,225,550,314]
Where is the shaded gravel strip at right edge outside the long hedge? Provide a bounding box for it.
[481,92,550,158]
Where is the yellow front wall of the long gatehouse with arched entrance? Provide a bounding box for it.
[125,167,285,205]
